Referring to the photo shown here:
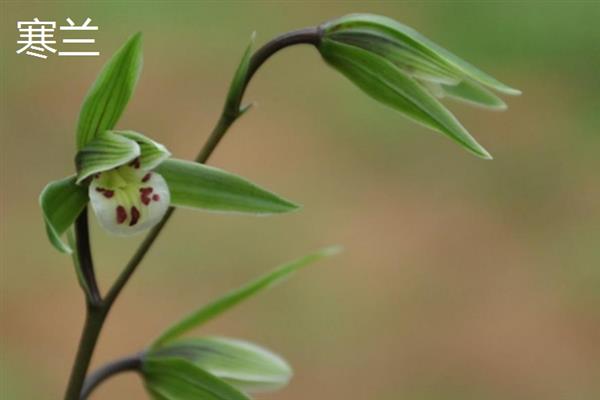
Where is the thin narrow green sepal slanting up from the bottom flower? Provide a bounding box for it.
[152,247,340,348]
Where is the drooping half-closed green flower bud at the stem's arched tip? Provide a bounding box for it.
[317,14,520,158]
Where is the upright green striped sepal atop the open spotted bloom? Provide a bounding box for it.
[77,33,142,149]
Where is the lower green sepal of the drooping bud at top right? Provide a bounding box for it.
[319,39,491,159]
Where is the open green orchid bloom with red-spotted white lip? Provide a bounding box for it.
[40,34,298,253]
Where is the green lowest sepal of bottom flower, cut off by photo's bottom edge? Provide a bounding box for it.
[142,358,249,400]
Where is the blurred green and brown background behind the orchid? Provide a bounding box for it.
[0,1,600,400]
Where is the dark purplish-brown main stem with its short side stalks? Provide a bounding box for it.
[64,27,321,400]
